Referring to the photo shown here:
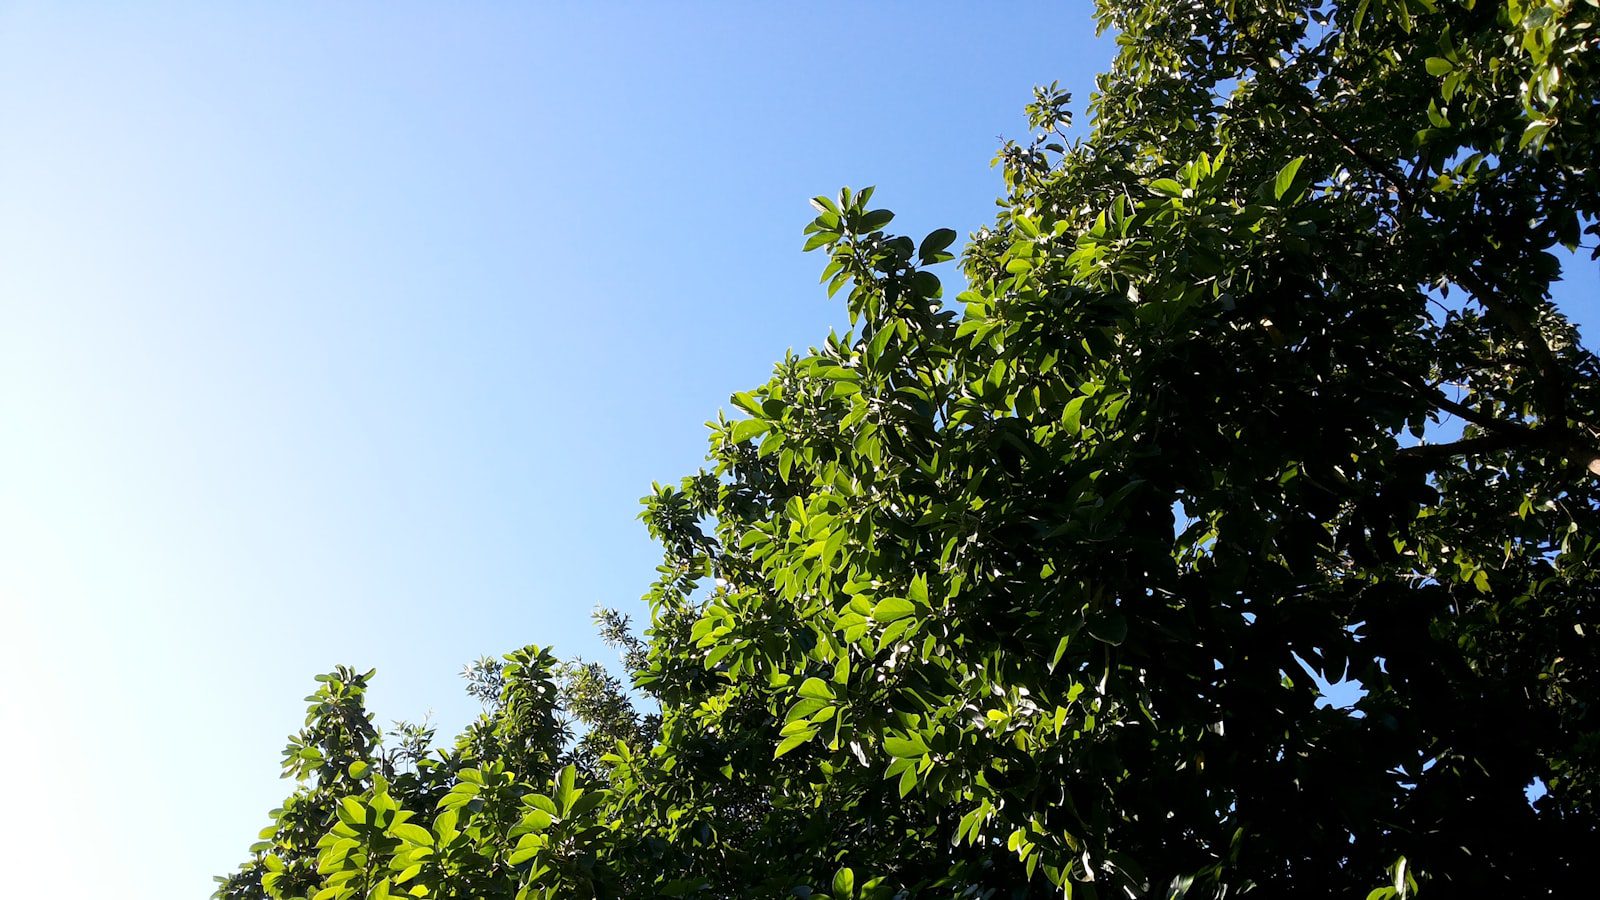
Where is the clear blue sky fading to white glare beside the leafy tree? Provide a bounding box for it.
[0,0,1595,900]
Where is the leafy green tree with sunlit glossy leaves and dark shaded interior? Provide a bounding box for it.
[219,0,1600,900]
